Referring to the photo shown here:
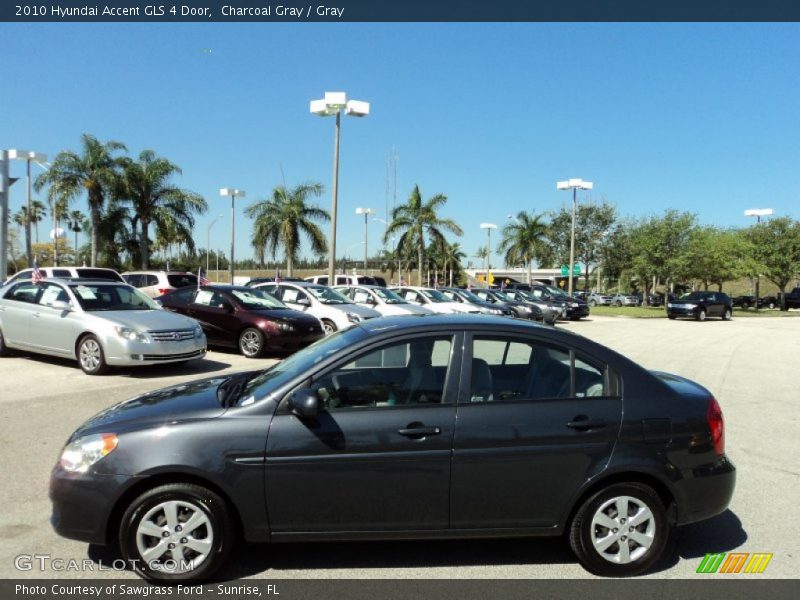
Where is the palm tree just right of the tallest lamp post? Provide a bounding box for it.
[383,185,464,285]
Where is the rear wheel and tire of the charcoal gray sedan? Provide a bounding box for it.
[569,483,670,577]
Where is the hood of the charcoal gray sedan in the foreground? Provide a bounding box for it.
[70,375,230,441]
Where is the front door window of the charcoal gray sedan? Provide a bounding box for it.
[311,336,452,410]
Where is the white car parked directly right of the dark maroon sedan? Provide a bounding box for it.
[253,281,381,335]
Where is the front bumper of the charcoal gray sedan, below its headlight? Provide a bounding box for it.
[49,465,135,545]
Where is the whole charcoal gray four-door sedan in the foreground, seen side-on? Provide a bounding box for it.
[50,315,735,580]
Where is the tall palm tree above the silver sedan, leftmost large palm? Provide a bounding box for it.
[34,133,126,267]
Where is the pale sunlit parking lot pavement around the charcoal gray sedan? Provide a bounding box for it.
[0,317,800,579]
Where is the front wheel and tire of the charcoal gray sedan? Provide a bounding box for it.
[119,483,235,582]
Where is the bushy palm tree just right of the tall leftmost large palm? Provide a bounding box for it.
[120,150,208,269]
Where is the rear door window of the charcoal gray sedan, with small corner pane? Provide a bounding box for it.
[469,336,605,402]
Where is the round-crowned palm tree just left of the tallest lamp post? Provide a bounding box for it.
[245,183,330,277]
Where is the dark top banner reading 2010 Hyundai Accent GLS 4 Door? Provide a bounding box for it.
[0,0,800,23]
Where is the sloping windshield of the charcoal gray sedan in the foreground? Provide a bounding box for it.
[240,327,367,405]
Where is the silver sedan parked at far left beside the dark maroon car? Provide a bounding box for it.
[0,279,206,375]
